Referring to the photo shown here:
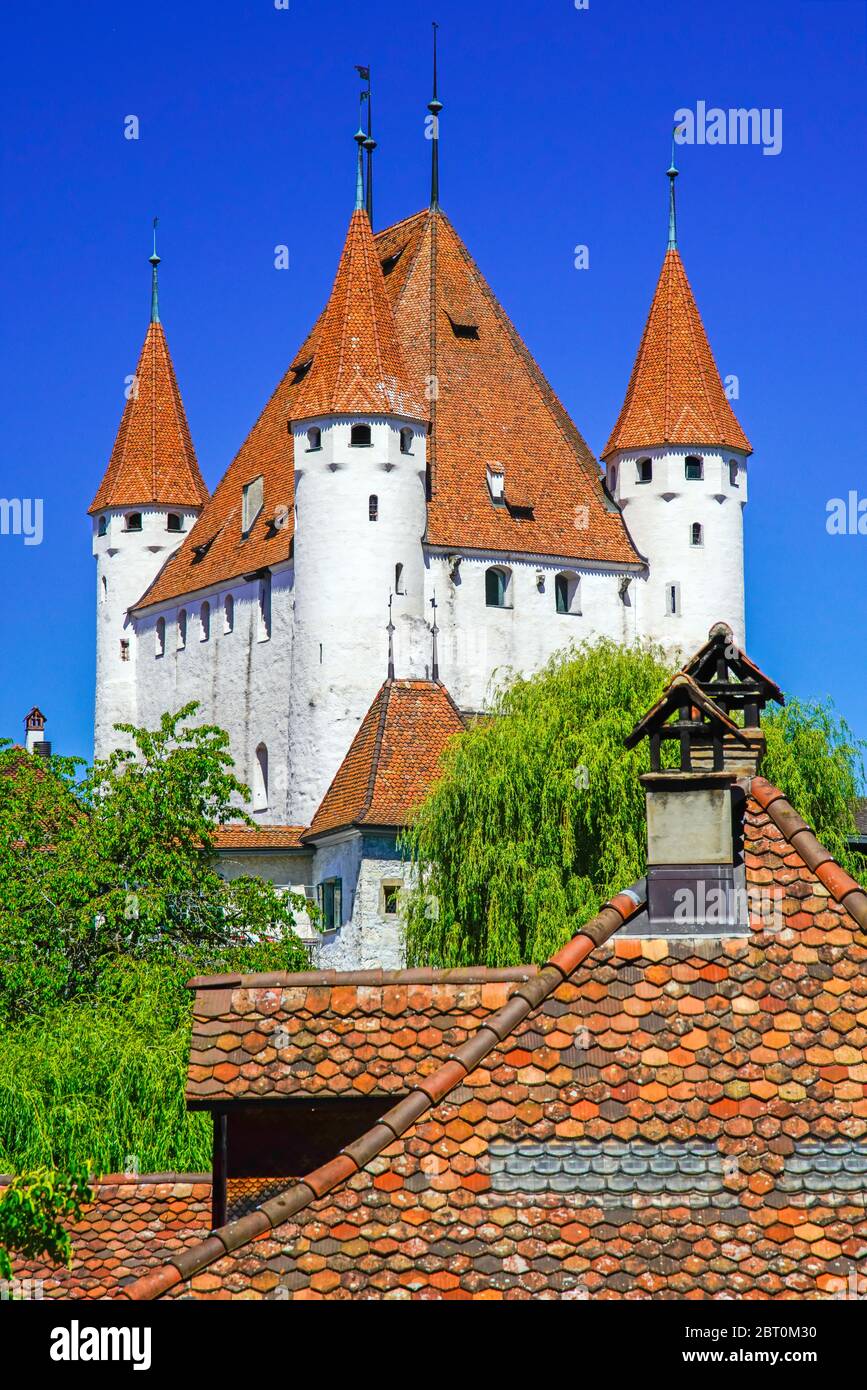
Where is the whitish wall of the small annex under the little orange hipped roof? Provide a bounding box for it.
[314,831,410,970]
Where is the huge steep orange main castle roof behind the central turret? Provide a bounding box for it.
[139,210,639,606]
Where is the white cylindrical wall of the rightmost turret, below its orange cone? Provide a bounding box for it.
[609,448,748,657]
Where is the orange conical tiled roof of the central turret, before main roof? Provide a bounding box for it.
[293,209,428,420]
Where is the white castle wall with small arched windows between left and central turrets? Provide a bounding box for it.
[136,567,294,824]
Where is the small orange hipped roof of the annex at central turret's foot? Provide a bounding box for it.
[304,680,464,840]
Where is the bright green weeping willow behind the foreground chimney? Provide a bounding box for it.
[403,641,863,967]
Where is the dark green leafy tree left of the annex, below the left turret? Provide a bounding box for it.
[0,705,309,1017]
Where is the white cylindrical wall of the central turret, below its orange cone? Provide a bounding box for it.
[288,416,427,824]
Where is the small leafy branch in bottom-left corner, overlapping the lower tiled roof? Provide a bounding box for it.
[0,1168,93,1279]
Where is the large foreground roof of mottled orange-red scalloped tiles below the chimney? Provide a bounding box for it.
[115,777,867,1300]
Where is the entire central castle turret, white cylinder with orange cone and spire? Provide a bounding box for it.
[289,131,428,824]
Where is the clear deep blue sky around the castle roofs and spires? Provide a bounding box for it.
[0,0,867,756]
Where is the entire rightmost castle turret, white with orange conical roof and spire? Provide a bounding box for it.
[603,153,752,653]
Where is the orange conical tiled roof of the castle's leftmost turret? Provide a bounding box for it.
[89,322,208,513]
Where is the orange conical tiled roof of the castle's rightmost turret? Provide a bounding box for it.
[602,247,752,459]
